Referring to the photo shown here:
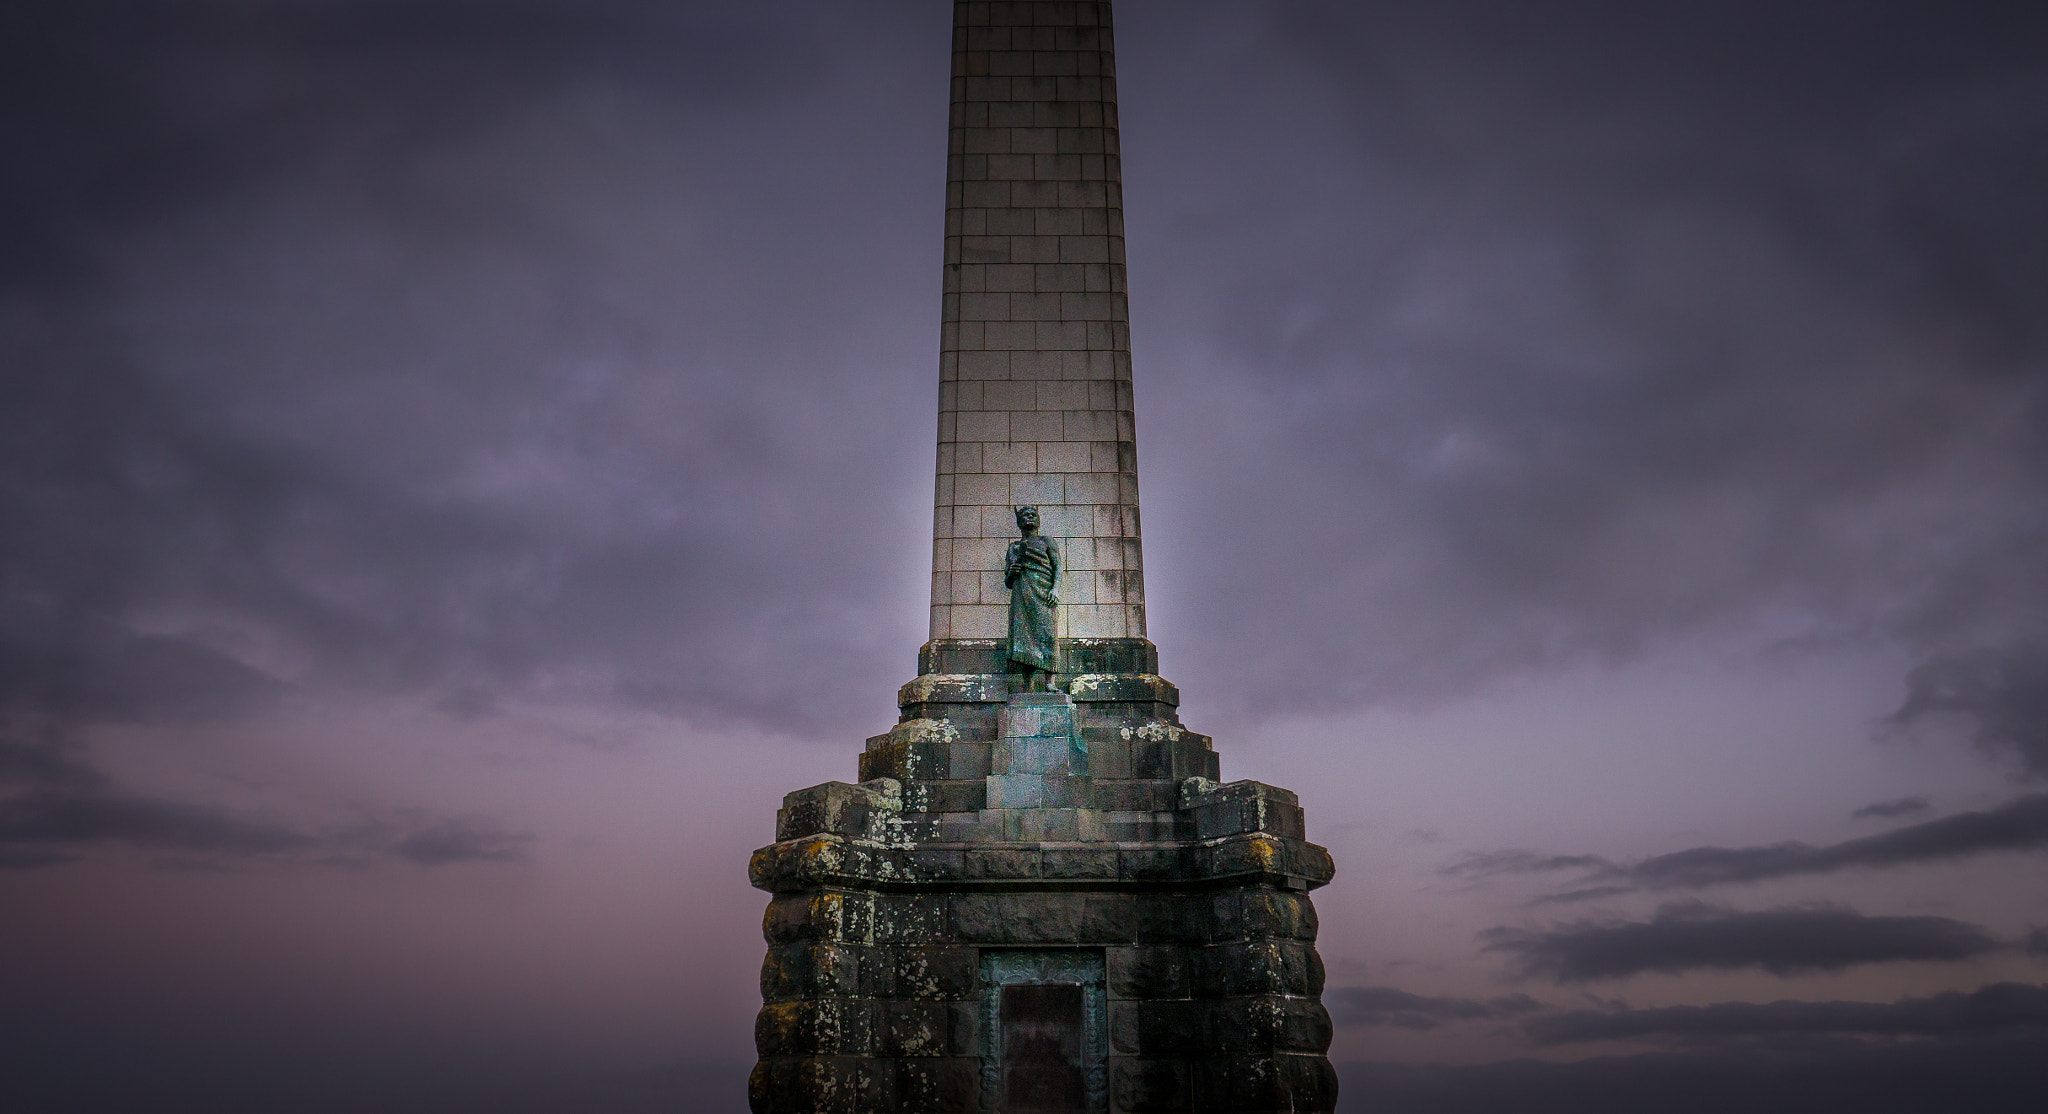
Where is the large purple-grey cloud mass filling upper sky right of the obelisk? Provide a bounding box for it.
[1120,2,2048,709]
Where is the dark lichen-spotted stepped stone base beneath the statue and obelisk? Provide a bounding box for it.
[750,639,1337,1114]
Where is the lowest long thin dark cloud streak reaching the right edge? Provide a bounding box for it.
[1522,983,2048,1044]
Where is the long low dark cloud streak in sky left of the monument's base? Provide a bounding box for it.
[0,735,532,870]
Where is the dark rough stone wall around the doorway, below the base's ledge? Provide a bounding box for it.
[752,887,1337,1114]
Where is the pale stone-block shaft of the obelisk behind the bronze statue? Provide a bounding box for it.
[932,0,1145,639]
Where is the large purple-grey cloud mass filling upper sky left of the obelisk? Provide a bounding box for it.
[0,0,944,745]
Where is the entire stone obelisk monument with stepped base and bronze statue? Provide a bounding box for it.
[752,2,1337,1114]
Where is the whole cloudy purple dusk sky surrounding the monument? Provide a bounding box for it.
[0,0,2048,1112]
